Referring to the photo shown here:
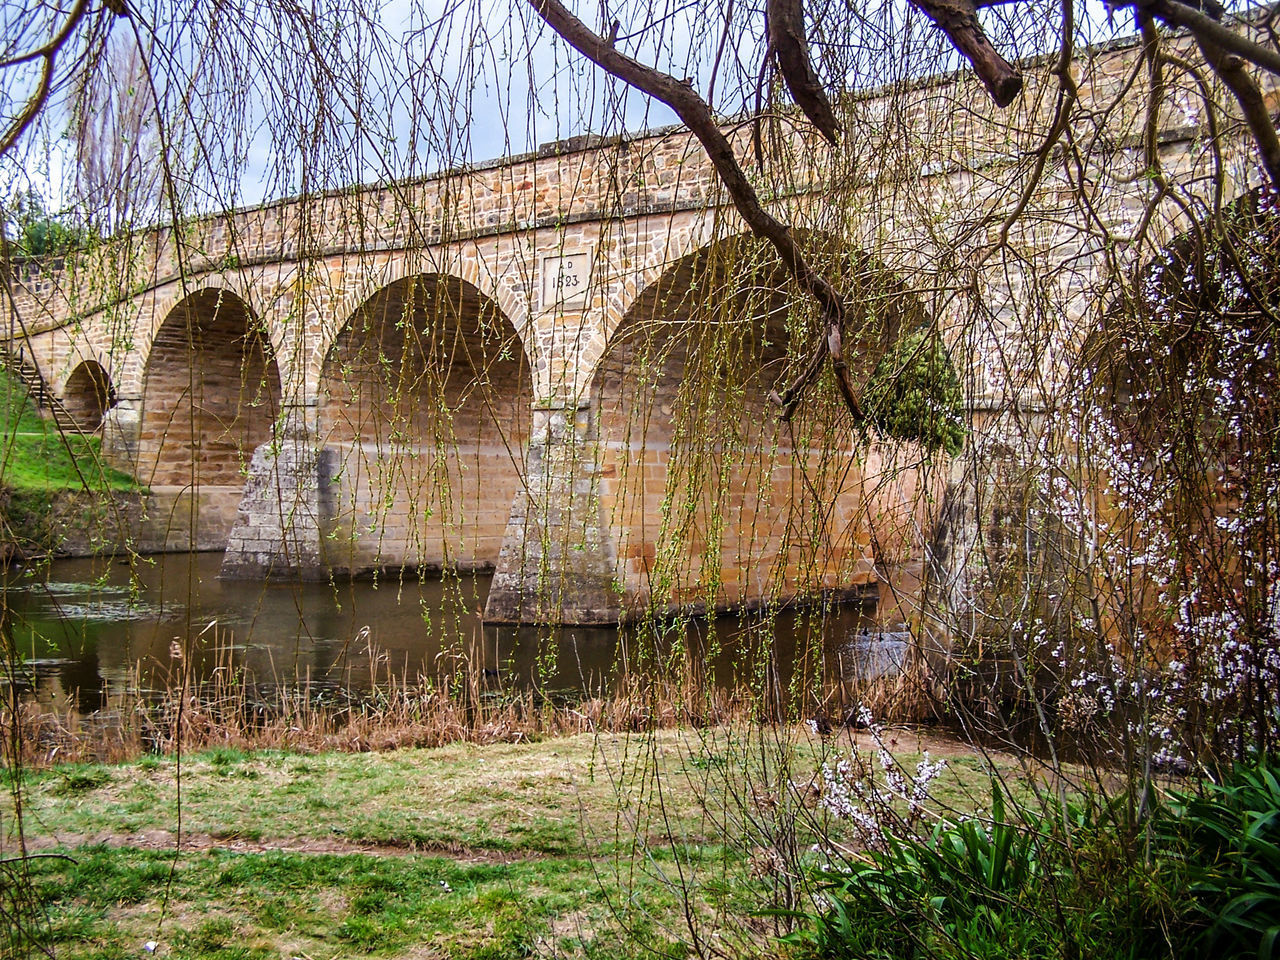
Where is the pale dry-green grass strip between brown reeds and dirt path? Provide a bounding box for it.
[7,730,1008,855]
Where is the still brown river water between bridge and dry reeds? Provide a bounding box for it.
[4,553,872,713]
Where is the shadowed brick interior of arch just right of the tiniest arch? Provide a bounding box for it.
[138,285,282,490]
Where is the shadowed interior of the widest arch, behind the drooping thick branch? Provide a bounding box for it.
[589,236,947,624]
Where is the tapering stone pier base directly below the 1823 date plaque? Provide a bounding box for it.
[484,403,622,625]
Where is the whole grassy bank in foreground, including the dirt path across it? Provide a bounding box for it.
[4,724,1012,960]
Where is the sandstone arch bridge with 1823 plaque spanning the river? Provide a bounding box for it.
[0,35,1248,622]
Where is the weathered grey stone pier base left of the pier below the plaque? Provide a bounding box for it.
[219,403,338,580]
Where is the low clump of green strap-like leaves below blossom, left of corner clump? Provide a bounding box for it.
[786,786,1189,960]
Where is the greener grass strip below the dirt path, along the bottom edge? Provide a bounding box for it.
[20,846,691,960]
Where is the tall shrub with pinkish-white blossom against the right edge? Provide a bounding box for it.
[1027,192,1280,771]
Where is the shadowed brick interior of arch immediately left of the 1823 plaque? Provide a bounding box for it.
[319,274,534,575]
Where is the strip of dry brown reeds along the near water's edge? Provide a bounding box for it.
[0,632,936,768]
